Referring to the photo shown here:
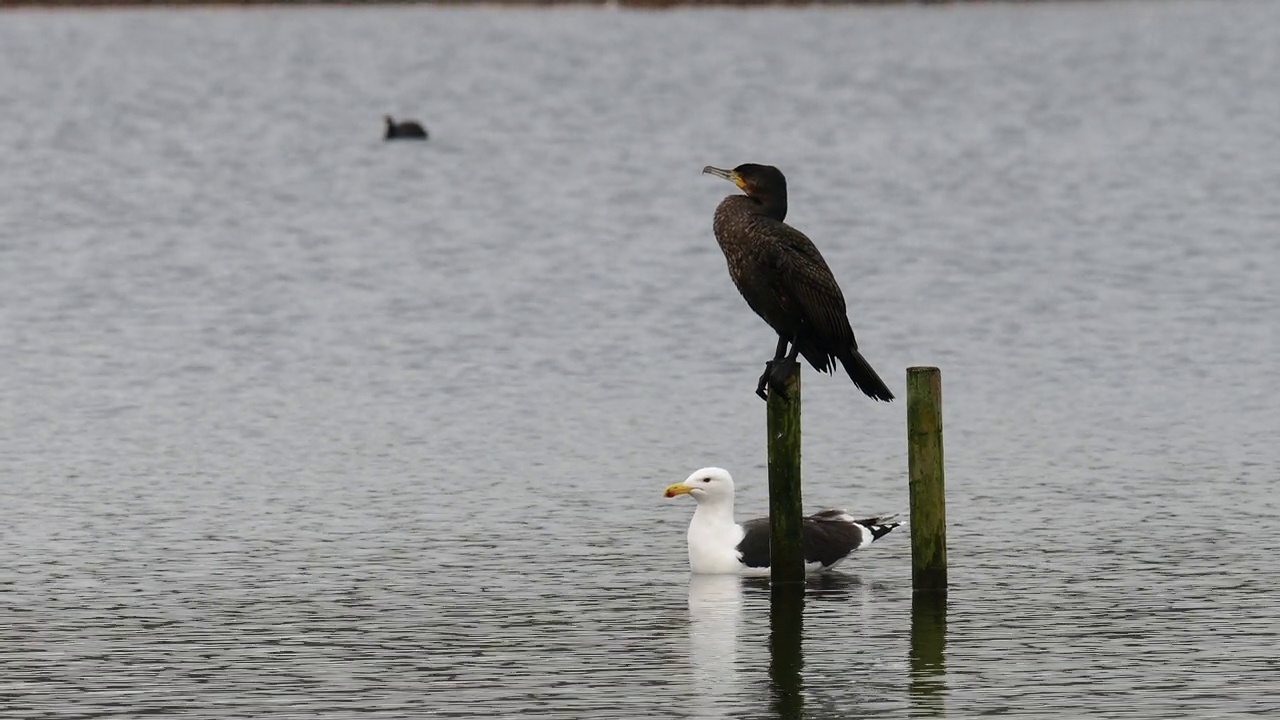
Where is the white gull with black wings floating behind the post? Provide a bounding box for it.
[667,468,902,577]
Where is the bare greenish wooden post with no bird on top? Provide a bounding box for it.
[906,368,947,593]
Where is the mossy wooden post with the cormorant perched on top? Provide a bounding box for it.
[765,363,804,583]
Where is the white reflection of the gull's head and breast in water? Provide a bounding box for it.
[689,575,742,717]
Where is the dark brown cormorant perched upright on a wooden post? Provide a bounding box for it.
[703,163,893,401]
